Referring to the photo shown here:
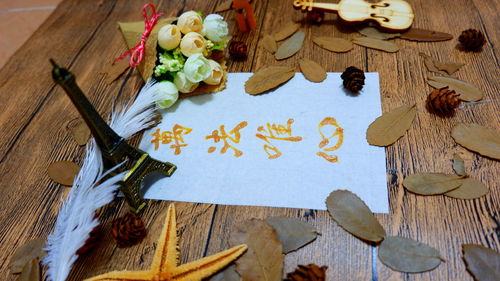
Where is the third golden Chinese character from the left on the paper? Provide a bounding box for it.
[255,118,302,159]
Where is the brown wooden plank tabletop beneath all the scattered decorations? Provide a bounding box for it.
[0,0,500,281]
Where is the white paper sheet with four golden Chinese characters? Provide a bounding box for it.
[140,73,388,213]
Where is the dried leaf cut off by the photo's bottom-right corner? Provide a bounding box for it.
[462,244,500,281]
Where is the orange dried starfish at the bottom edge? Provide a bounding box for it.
[86,204,248,281]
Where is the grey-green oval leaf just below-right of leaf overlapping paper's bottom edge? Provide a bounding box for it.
[378,236,442,273]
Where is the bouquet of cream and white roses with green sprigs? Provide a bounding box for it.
[153,11,230,108]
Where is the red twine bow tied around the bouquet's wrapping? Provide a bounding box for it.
[114,4,163,67]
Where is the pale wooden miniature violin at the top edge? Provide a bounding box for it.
[293,0,415,30]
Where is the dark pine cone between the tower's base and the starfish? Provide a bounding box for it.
[111,212,147,248]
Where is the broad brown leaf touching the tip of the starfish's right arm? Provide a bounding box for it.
[230,219,284,281]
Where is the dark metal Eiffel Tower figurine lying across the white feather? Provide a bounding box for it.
[50,59,176,214]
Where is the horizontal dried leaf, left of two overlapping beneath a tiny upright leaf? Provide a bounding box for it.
[403,173,463,195]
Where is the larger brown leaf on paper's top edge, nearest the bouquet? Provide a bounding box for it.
[245,66,295,95]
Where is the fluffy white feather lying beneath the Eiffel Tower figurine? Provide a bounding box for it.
[43,81,159,281]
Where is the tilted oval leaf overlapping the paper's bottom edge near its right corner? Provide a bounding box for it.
[326,190,386,242]
